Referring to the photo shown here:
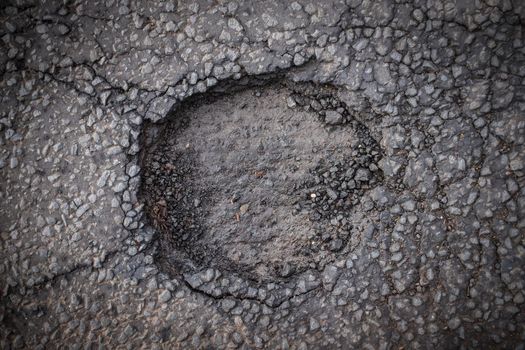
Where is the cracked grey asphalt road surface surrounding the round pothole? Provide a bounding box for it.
[0,0,525,349]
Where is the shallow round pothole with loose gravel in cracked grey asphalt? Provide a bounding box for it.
[140,82,382,288]
